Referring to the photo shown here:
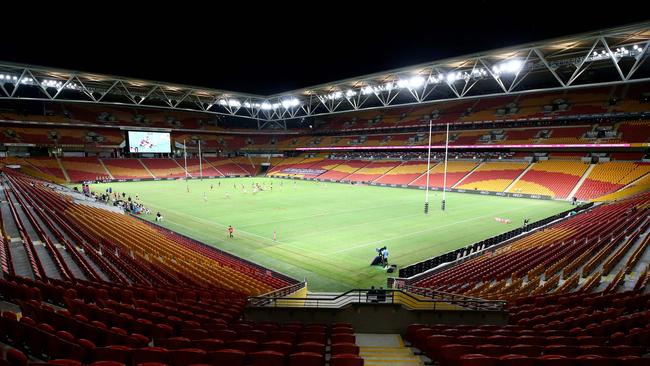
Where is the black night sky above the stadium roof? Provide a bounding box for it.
[0,0,647,95]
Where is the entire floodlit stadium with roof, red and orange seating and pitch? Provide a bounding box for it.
[0,17,650,366]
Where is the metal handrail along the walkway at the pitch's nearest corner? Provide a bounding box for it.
[247,288,506,311]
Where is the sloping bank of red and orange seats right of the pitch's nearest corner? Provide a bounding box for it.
[413,193,650,299]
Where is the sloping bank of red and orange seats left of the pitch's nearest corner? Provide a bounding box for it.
[3,172,289,294]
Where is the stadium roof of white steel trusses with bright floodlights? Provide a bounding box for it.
[0,22,650,126]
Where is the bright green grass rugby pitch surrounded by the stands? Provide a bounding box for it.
[91,177,570,291]
